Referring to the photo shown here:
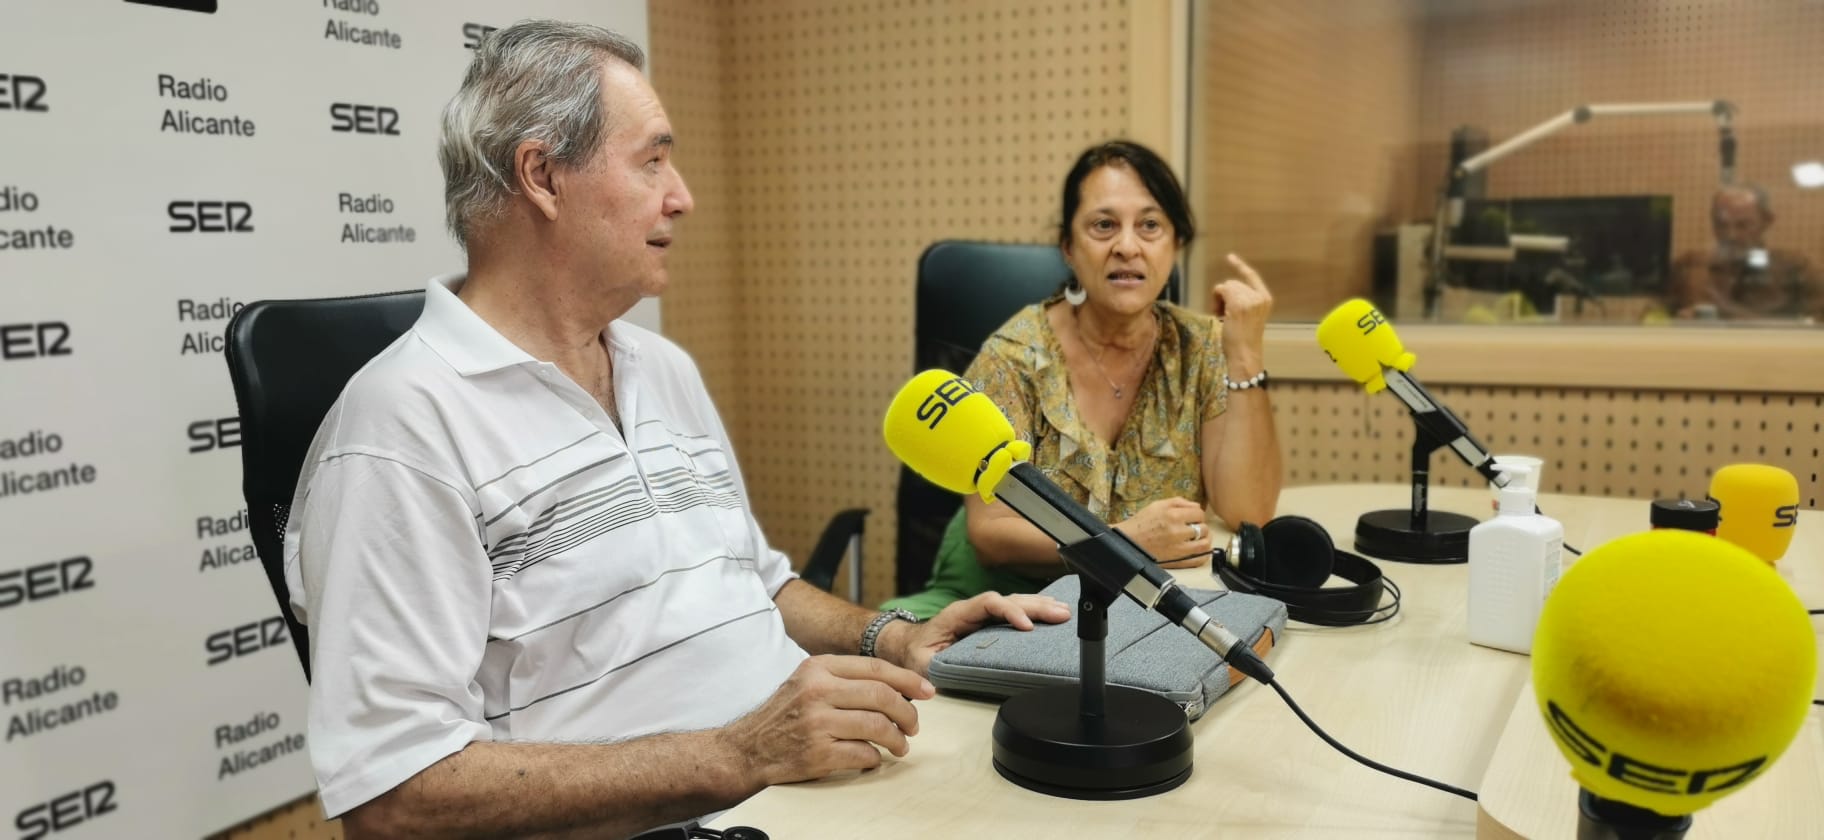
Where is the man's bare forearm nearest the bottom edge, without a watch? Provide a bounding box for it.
[343,731,761,838]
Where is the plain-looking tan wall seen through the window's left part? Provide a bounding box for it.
[1189,0,1423,319]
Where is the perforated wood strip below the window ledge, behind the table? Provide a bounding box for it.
[1273,383,1824,510]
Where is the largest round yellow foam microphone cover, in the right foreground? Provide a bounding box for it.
[1532,530,1817,816]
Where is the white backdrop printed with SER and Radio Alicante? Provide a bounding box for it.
[0,0,657,840]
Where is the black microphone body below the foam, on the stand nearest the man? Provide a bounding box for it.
[994,461,1273,683]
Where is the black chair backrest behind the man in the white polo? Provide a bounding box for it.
[226,292,425,680]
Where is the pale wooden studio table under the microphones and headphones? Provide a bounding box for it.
[717,485,1824,840]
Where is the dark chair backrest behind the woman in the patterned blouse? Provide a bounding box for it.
[894,239,1182,594]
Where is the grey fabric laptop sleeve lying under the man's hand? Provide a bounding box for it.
[930,574,1286,720]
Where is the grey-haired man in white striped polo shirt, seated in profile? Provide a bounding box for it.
[286,22,1067,836]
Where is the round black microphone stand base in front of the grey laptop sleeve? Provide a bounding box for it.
[994,683,1193,800]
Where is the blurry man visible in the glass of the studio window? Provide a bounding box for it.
[1669,184,1824,321]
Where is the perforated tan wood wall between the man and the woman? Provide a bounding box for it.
[651,0,1129,603]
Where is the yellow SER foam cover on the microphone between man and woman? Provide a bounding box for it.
[881,370,1032,501]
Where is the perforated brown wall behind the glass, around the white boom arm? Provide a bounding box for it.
[1412,0,1824,287]
